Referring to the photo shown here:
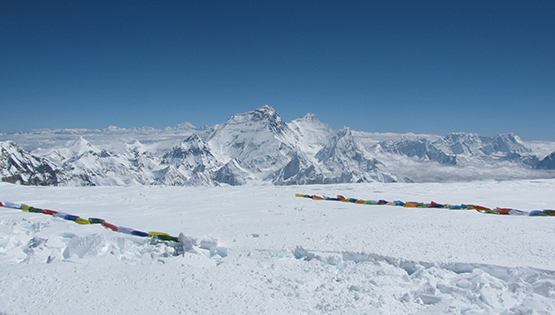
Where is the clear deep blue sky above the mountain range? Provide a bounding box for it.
[0,0,555,140]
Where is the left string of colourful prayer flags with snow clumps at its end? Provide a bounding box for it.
[0,201,227,257]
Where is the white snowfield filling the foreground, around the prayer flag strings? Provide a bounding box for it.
[0,180,555,314]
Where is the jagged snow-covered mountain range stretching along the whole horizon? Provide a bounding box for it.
[0,106,555,186]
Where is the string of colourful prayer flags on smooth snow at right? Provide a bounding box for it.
[295,193,555,217]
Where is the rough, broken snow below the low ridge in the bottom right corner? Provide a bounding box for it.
[293,247,555,314]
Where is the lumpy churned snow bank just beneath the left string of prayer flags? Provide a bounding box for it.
[0,217,227,264]
